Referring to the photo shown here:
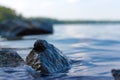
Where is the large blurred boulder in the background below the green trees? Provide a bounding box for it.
[0,19,53,37]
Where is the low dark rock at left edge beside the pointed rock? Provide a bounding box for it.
[0,50,25,67]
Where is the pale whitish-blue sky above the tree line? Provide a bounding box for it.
[0,0,120,20]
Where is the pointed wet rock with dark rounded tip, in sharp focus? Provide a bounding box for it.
[26,40,70,74]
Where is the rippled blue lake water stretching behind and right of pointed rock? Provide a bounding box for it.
[0,24,120,80]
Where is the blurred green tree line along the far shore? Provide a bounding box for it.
[0,6,120,24]
